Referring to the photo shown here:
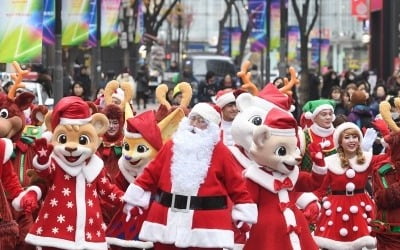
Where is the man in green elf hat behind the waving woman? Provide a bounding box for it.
[301,100,336,172]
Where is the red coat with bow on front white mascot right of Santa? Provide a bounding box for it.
[229,147,327,250]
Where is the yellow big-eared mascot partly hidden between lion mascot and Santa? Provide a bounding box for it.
[106,106,184,250]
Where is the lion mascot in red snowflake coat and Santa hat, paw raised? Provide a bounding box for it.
[25,96,123,249]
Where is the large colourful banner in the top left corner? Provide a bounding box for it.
[0,0,43,63]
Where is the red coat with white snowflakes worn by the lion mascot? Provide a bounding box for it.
[25,154,123,249]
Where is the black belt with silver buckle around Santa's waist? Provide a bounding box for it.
[155,190,227,212]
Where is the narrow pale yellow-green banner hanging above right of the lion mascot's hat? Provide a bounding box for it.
[101,0,121,47]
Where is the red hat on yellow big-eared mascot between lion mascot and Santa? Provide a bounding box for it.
[124,110,163,150]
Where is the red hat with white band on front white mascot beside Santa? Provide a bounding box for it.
[264,108,297,136]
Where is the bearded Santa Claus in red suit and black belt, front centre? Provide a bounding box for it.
[124,103,257,250]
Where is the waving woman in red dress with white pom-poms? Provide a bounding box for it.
[314,122,387,249]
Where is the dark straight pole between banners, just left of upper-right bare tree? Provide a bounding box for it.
[278,0,288,77]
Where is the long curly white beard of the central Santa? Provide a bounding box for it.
[171,117,220,195]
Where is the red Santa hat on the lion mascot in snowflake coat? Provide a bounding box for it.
[51,96,92,131]
